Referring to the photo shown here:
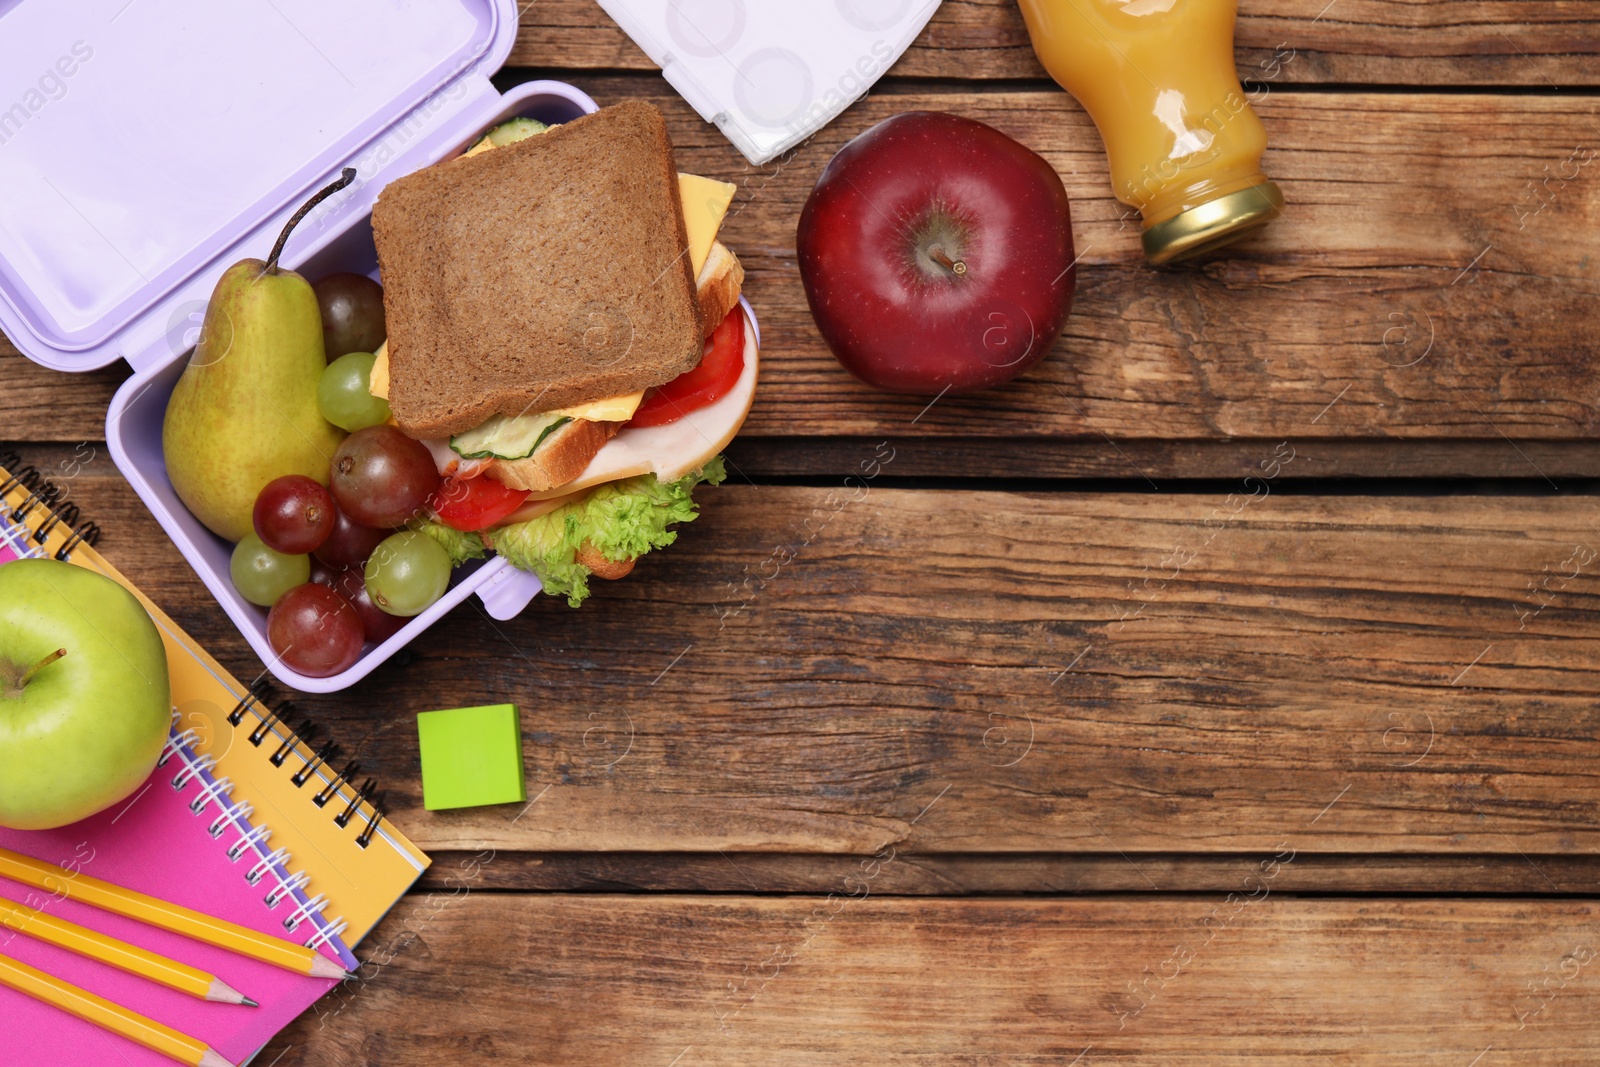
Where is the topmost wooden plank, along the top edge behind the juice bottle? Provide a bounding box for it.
[510,0,1600,88]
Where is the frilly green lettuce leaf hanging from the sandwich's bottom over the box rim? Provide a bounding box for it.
[486,456,728,608]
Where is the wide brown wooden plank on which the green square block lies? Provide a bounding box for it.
[28,453,1600,856]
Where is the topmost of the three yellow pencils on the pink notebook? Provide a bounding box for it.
[0,848,350,979]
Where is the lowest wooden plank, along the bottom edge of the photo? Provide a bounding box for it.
[262,895,1600,1067]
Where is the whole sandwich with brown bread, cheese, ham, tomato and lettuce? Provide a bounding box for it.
[370,102,758,606]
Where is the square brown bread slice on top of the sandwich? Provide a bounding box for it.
[373,101,704,438]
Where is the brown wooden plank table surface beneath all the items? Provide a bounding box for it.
[0,0,1600,1067]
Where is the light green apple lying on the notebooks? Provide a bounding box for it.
[0,560,173,830]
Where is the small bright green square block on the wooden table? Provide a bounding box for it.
[416,704,528,811]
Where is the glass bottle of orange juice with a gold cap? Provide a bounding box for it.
[1019,0,1283,262]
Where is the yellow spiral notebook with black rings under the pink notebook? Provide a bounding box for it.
[0,454,429,966]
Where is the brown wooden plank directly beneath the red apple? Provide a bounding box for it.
[15,78,1600,447]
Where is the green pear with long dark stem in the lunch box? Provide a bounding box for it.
[162,171,355,541]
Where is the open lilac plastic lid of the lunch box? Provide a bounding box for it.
[0,0,517,371]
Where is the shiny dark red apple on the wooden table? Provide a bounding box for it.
[797,112,1074,394]
